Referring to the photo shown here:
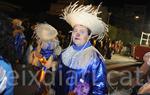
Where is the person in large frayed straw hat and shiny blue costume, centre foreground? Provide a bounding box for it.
[55,2,108,95]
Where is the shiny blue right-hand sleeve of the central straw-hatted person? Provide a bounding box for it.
[92,58,107,95]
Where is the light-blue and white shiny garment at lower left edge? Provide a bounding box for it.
[0,56,14,95]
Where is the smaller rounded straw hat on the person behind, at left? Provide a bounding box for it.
[34,23,58,42]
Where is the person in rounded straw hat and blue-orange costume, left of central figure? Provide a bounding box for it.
[28,23,61,95]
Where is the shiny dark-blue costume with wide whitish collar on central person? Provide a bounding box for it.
[55,42,107,95]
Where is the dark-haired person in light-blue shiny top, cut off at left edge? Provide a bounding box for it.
[0,32,16,95]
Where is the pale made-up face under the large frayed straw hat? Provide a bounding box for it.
[72,25,89,46]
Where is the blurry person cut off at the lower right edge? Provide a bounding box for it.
[131,52,150,95]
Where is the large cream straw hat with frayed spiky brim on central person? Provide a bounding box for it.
[61,1,108,40]
